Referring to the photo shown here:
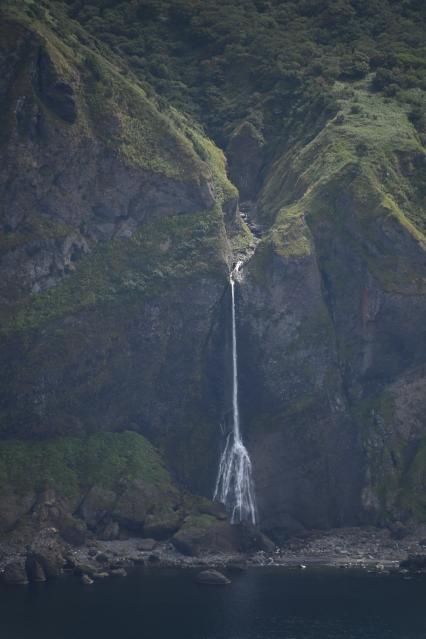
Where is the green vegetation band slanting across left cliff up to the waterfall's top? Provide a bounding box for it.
[2,208,225,332]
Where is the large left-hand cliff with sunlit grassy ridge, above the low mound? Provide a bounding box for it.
[1,7,236,500]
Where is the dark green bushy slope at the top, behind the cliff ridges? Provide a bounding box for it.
[61,0,426,151]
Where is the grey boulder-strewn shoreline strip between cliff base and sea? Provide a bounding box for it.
[0,527,426,584]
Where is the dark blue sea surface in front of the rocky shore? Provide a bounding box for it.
[0,568,426,639]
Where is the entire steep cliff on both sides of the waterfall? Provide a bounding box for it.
[0,1,426,539]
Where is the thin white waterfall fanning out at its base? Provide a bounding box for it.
[213,262,256,524]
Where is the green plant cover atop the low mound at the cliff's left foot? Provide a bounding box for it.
[0,432,176,499]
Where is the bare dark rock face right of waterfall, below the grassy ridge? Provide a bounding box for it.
[239,160,426,528]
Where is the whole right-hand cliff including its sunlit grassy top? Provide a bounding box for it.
[240,82,426,533]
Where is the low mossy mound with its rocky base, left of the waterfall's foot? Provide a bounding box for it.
[0,432,185,545]
